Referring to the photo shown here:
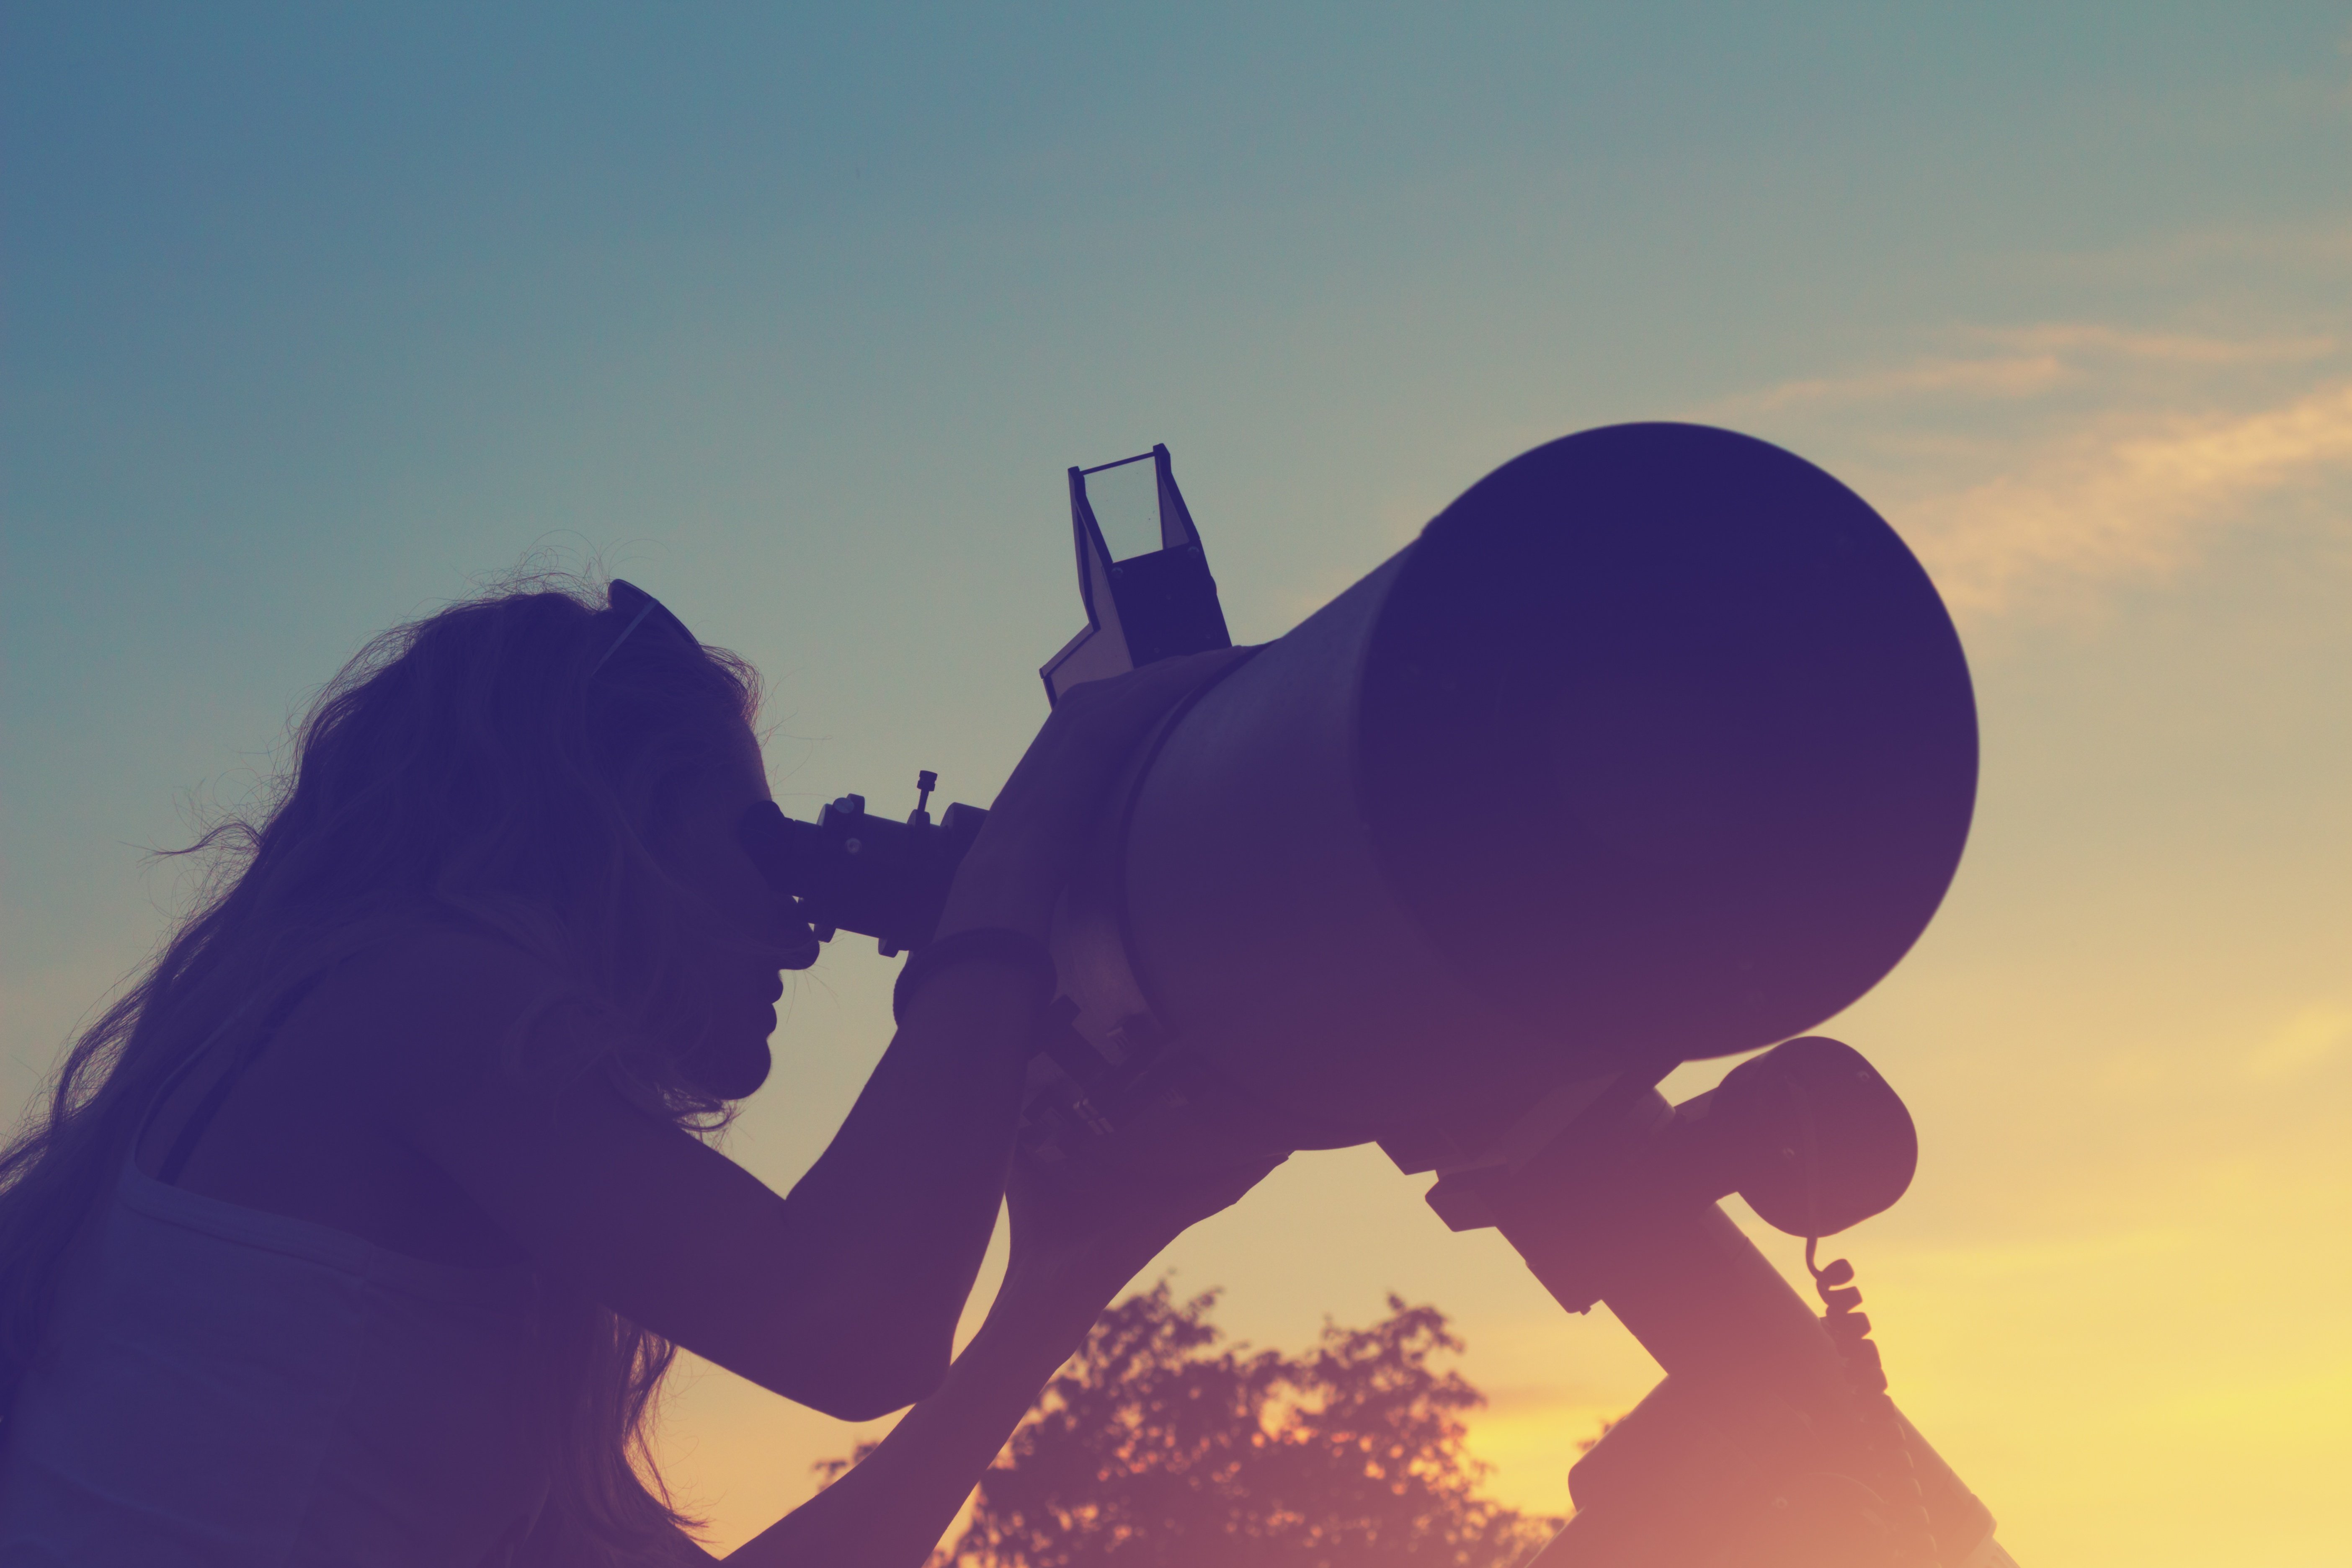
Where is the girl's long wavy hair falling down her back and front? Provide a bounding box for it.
[0,574,760,1568]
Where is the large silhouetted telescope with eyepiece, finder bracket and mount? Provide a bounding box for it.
[743,423,2011,1568]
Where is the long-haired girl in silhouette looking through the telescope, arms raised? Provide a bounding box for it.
[0,580,1268,1568]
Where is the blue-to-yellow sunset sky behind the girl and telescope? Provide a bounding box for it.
[0,0,2352,1568]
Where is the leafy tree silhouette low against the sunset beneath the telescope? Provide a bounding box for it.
[828,1281,1562,1568]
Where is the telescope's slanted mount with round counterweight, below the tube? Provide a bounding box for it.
[1421,1037,2009,1568]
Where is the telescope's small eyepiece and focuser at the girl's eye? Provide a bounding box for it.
[736,769,988,957]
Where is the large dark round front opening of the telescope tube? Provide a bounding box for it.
[1359,423,1975,1065]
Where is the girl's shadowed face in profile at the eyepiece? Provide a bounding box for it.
[663,726,816,1100]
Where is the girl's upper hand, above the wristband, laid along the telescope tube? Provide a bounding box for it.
[939,649,1249,940]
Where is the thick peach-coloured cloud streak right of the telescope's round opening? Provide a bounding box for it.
[1891,381,2352,616]
